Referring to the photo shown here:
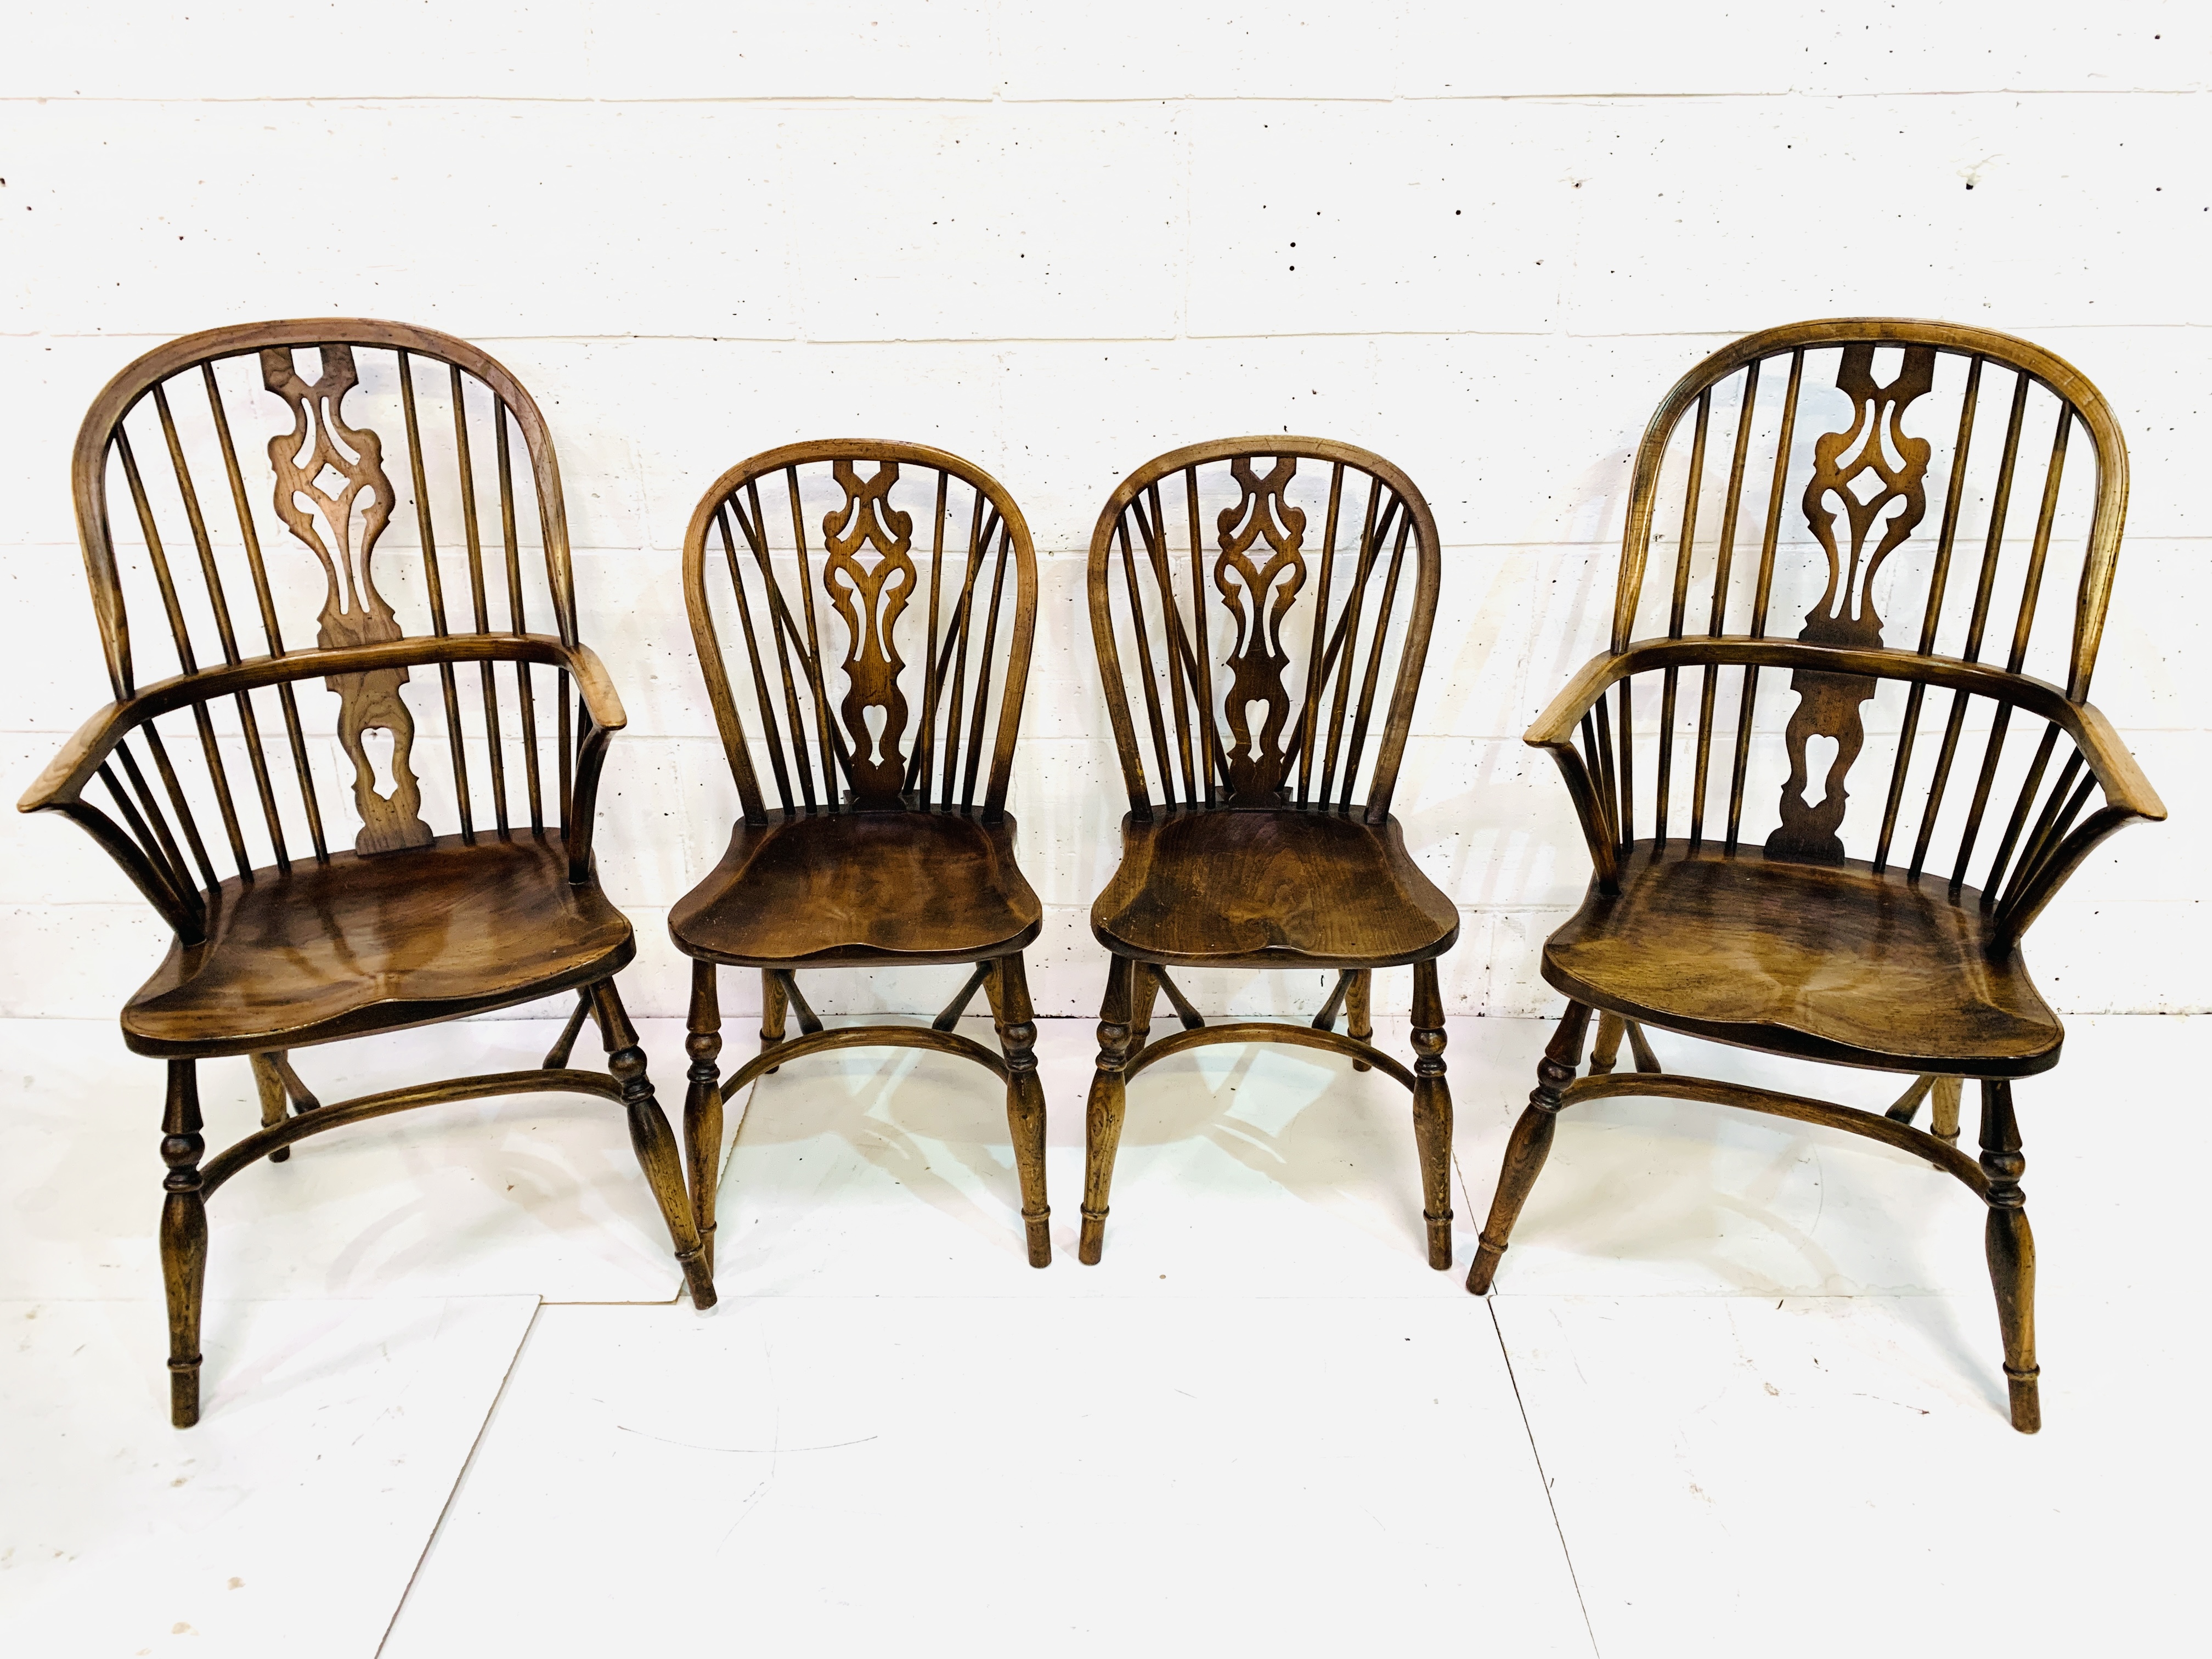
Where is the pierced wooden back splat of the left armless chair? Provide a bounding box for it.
[823,460,913,808]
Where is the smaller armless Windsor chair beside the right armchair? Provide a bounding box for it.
[1080,438,1460,1267]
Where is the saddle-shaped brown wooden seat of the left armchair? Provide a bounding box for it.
[124,834,635,1055]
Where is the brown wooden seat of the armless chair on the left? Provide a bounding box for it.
[668,810,1044,969]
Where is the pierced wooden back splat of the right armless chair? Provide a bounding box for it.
[1215,456,1305,805]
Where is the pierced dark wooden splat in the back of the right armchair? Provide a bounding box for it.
[1768,345,1936,865]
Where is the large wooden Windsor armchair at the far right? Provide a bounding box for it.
[1466,319,2165,1434]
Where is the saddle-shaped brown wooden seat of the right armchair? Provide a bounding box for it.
[1544,840,2066,1077]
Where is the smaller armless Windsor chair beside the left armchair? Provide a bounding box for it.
[668,440,1053,1267]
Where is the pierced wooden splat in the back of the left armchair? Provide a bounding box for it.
[261,345,431,854]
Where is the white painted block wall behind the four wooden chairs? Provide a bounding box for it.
[0,0,2212,1018]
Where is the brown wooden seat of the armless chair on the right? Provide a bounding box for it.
[1091,808,1460,969]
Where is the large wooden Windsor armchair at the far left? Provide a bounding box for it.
[22,319,714,1429]
